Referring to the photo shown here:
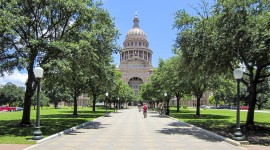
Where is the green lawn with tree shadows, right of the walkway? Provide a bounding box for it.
[170,108,270,145]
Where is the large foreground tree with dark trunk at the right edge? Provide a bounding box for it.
[213,1,270,126]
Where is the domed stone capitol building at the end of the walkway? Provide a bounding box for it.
[117,15,153,95]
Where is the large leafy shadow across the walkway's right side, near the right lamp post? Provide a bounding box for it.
[157,122,223,142]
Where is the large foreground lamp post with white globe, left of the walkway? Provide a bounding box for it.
[32,67,43,140]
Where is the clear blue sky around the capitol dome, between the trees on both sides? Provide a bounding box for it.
[103,0,213,67]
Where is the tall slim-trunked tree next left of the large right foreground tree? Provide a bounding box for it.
[175,3,214,116]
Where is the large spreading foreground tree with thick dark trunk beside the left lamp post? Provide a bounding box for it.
[0,0,118,125]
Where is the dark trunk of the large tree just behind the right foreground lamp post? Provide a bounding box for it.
[246,82,257,126]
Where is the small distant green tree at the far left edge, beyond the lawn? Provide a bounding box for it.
[0,82,24,106]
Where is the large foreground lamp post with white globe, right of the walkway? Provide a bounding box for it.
[233,68,244,141]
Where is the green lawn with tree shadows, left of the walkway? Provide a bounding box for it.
[0,108,112,144]
